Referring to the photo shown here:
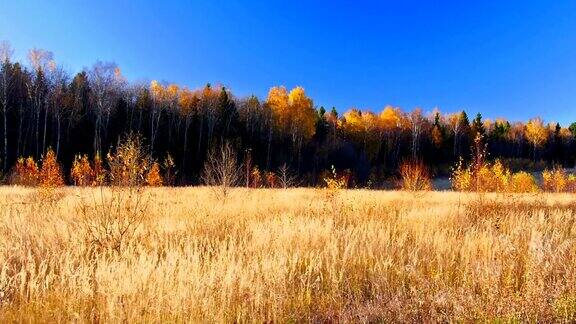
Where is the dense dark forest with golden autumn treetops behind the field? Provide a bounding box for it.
[0,42,576,186]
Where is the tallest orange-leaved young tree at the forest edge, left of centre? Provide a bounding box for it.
[107,134,153,187]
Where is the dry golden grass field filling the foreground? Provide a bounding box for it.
[0,187,576,322]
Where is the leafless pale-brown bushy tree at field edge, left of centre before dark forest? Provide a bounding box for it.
[202,143,242,198]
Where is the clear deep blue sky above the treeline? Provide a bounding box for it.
[0,0,576,123]
